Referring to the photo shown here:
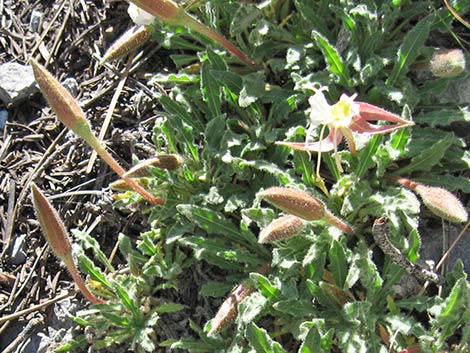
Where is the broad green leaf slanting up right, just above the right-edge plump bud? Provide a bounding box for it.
[395,134,455,175]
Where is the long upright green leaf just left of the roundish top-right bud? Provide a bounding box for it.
[386,15,434,86]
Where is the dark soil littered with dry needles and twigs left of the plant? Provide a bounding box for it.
[0,0,185,352]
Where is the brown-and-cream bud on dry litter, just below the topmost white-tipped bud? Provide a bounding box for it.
[100,26,150,64]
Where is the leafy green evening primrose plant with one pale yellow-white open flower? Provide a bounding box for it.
[29,0,470,353]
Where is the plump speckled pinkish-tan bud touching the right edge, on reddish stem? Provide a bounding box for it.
[413,184,468,223]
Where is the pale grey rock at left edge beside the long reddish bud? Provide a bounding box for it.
[0,63,38,106]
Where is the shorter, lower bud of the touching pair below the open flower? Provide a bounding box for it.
[258,215,305,244]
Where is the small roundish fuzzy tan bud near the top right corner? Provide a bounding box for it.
[429,49,465,78]
